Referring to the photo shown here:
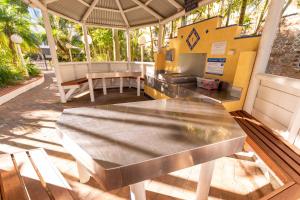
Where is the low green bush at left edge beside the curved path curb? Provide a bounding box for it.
[0,65,23,87]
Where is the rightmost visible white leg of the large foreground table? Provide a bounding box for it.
[196,161,215,200]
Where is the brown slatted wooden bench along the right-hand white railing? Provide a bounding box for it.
[231,111,300,200]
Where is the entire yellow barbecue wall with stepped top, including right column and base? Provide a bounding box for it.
[149,17,260,111]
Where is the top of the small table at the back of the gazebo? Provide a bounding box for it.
[86,72,142,79]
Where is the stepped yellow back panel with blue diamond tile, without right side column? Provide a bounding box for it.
[156,17,260,83]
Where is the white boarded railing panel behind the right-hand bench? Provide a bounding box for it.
[252,74,300,148]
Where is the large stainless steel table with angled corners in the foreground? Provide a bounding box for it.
[57,98,246,200]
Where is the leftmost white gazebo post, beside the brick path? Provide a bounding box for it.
[41,9,66,103]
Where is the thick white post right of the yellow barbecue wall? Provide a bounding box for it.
[244,0,285,114]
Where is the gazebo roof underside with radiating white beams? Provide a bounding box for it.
[25,0,214,29]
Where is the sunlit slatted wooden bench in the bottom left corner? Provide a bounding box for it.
[0,149,76,200]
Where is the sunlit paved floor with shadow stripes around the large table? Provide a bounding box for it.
[0,73,273,200]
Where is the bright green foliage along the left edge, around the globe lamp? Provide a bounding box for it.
[0,0,41,87]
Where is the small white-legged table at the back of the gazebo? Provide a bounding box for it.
[86,72,142,102]
